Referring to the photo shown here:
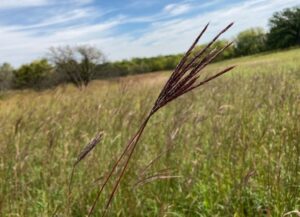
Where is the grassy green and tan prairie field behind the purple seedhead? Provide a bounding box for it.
[0,49,300,217]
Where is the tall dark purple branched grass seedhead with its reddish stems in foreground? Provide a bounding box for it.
[88,23,234,216]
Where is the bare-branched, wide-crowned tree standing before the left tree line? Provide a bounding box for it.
[49,45,105,89]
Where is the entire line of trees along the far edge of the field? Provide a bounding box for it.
[0,7,300,90]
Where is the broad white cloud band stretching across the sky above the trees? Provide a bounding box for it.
[0,0,299,66]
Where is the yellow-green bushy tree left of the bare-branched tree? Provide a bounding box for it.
[14,59,52,88]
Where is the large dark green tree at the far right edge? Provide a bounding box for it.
[268,7,300,49]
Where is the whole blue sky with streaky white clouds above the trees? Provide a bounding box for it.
[0,0,300,67]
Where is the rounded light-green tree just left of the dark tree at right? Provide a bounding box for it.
[235,28,266,56]
